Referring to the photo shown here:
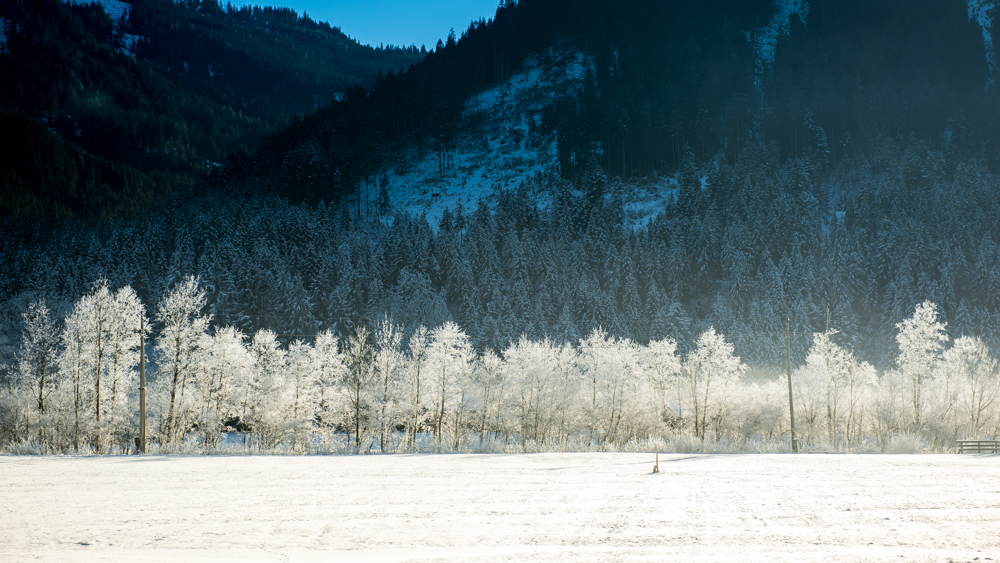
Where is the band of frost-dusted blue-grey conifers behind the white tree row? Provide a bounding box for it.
[0,136,1000,369]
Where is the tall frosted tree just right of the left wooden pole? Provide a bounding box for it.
[156,276,211,443]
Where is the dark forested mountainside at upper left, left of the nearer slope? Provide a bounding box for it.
[0,0,422,219]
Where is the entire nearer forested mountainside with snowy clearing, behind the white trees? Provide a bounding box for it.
[0,0,1000,376]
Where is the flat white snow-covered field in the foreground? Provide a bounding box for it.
[0,454,1000,562]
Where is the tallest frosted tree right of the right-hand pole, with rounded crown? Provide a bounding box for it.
[896,301,948,430]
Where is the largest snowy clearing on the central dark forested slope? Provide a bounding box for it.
[386,50,593,229]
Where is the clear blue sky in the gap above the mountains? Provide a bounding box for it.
[268,0,500,49]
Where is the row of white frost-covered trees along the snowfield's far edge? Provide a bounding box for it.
[0,278,1000,453]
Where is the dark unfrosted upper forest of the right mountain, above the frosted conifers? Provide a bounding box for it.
[227,0,1000,205]
